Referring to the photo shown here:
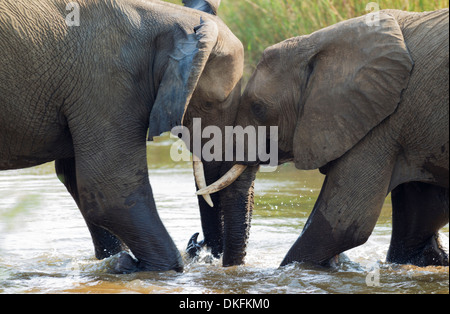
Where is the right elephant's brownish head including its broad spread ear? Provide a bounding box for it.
[201,12,413,177]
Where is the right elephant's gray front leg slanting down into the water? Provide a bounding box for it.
[281,140,395,266]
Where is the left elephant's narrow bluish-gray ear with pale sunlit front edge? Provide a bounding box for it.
[149,20,218,140]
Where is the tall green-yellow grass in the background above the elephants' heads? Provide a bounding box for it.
[169,0,449,77]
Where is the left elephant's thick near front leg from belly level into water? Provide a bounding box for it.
[72,126,182,272]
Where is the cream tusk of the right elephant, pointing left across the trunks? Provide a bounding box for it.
[196,150,293,196]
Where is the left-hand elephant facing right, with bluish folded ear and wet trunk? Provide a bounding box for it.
[0,0,254,272]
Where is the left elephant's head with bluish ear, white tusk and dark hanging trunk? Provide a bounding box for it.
[149,0,256,265]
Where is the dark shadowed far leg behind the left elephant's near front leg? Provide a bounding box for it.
[55,158,124,259]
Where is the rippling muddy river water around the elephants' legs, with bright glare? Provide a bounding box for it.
[0,142,449,294]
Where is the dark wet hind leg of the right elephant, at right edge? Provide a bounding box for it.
[387,182,449,266]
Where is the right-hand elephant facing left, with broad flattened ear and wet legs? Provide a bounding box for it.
[237,9,449,266]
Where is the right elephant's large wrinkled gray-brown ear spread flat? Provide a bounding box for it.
[293,12,413,169]
